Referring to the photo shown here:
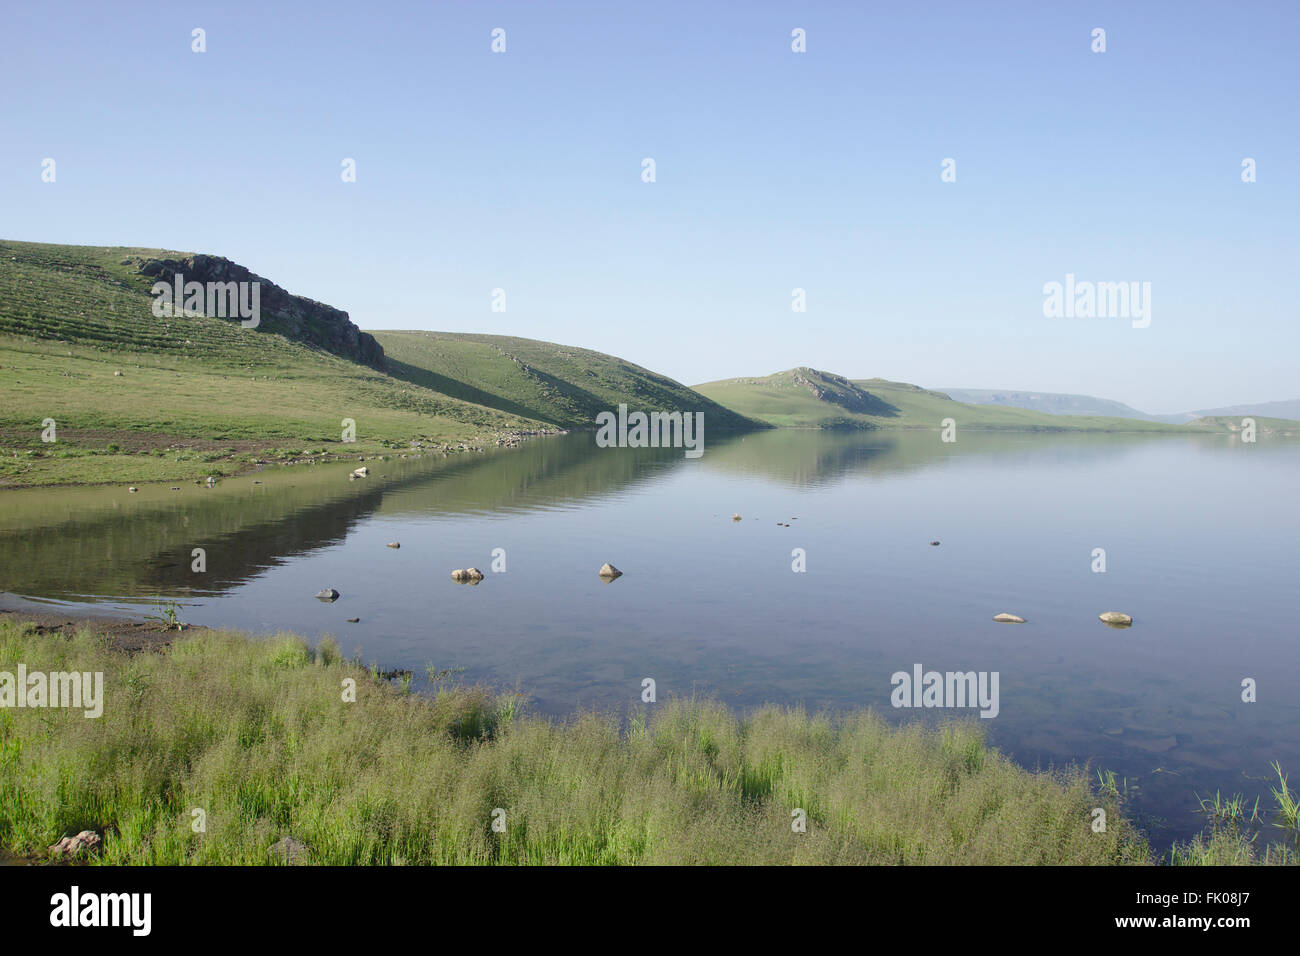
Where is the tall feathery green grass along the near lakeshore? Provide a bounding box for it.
[0,620,1149,864]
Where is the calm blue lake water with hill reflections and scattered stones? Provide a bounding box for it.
[0,431,1300,842]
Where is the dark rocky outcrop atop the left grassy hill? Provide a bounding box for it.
[138,255,387,372]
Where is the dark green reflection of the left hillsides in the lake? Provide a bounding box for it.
[0,434,681,598]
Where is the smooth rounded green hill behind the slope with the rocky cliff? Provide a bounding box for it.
[373,332,762,431]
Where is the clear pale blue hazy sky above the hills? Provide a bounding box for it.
[0,0,1300,412]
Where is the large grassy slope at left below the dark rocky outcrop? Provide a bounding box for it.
[0,241,546,485]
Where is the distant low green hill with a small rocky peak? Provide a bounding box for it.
[694,367,1179,432]
